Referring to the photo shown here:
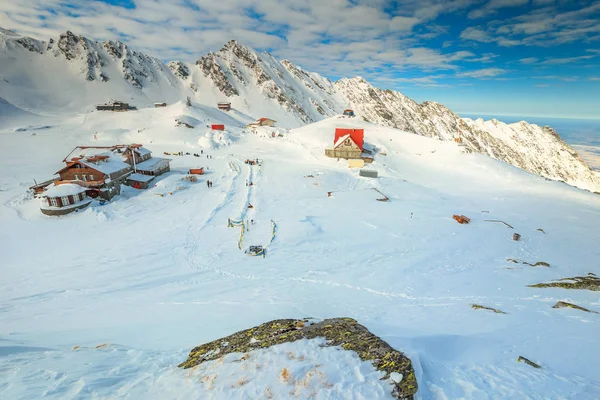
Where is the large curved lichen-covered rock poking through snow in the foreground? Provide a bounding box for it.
[179,318,418,400]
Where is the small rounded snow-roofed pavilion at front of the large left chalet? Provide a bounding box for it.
[40,183,92,215]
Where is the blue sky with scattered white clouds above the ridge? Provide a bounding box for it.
[0,0,600,118]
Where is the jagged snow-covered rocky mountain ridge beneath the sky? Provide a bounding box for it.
[0,28,600,191]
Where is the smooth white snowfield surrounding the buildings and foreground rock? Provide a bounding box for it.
[0,112,600,400]
